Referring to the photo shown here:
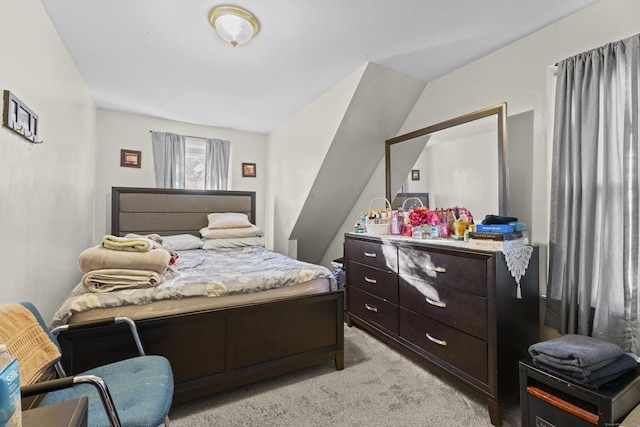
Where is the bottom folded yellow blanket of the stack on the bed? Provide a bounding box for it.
[81,268,162,292]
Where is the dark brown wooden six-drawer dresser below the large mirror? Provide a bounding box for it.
[344,233,539,426]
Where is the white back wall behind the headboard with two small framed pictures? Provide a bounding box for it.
[93,110,269,242]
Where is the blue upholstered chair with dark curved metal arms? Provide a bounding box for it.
[18,303,173,427]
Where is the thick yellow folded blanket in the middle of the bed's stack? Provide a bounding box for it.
[78,246,171,273]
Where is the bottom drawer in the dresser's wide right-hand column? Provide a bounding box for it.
[399,308,488,384]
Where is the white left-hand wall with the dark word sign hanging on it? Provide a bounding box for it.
[0,0,96,318]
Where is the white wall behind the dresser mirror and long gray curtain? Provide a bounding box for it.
[323,0,640,278]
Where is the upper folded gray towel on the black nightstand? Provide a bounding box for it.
[529,334,623,378]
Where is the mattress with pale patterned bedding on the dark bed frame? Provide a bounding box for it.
[50,246,336,327]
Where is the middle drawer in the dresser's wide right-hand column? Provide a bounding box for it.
[398,276,488,340]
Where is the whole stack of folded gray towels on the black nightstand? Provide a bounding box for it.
[529,334,637,388]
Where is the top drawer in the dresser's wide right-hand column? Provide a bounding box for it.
[398,247,491,297]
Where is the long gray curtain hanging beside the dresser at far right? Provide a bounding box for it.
[546,35,640,354]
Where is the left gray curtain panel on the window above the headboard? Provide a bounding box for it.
[151,132,185,188]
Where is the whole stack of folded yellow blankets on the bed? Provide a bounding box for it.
[78,235,173,292]
